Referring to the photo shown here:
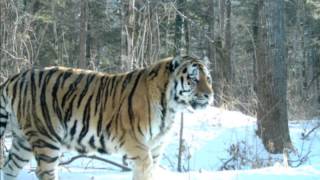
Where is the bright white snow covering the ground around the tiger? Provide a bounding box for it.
[0,108,320,180]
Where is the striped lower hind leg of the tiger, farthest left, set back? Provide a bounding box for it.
[4,137,33,180]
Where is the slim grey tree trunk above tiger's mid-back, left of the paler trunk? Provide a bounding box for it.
[79,0,88,68]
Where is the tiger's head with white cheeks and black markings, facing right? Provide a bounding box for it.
[171,56,213,109]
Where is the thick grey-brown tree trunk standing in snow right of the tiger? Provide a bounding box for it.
[257,0,291,153]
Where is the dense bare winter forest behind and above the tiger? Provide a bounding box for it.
[0,0,320,158]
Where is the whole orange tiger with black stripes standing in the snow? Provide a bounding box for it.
[0,56,213,180]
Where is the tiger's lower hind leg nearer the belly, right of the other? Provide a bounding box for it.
[33,141,60,180]
